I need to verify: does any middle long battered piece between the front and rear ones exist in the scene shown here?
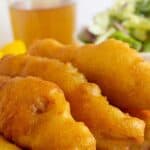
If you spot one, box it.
[0,55,145,150]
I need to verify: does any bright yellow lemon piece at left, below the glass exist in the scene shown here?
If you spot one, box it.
[0,41,27,58]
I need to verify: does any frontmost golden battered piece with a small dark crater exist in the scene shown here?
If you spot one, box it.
[0,77,96,150]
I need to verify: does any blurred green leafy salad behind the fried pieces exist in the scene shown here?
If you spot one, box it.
[79,0,150,52]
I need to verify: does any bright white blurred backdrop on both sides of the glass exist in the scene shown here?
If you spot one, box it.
[0,0,114,46]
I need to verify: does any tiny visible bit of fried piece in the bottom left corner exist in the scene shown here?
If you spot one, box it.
[0,136,21,150]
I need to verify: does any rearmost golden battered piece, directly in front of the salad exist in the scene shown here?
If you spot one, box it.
[30,39,150,109]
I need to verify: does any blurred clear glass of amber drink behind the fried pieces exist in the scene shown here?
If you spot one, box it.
[10,0,76,46]
